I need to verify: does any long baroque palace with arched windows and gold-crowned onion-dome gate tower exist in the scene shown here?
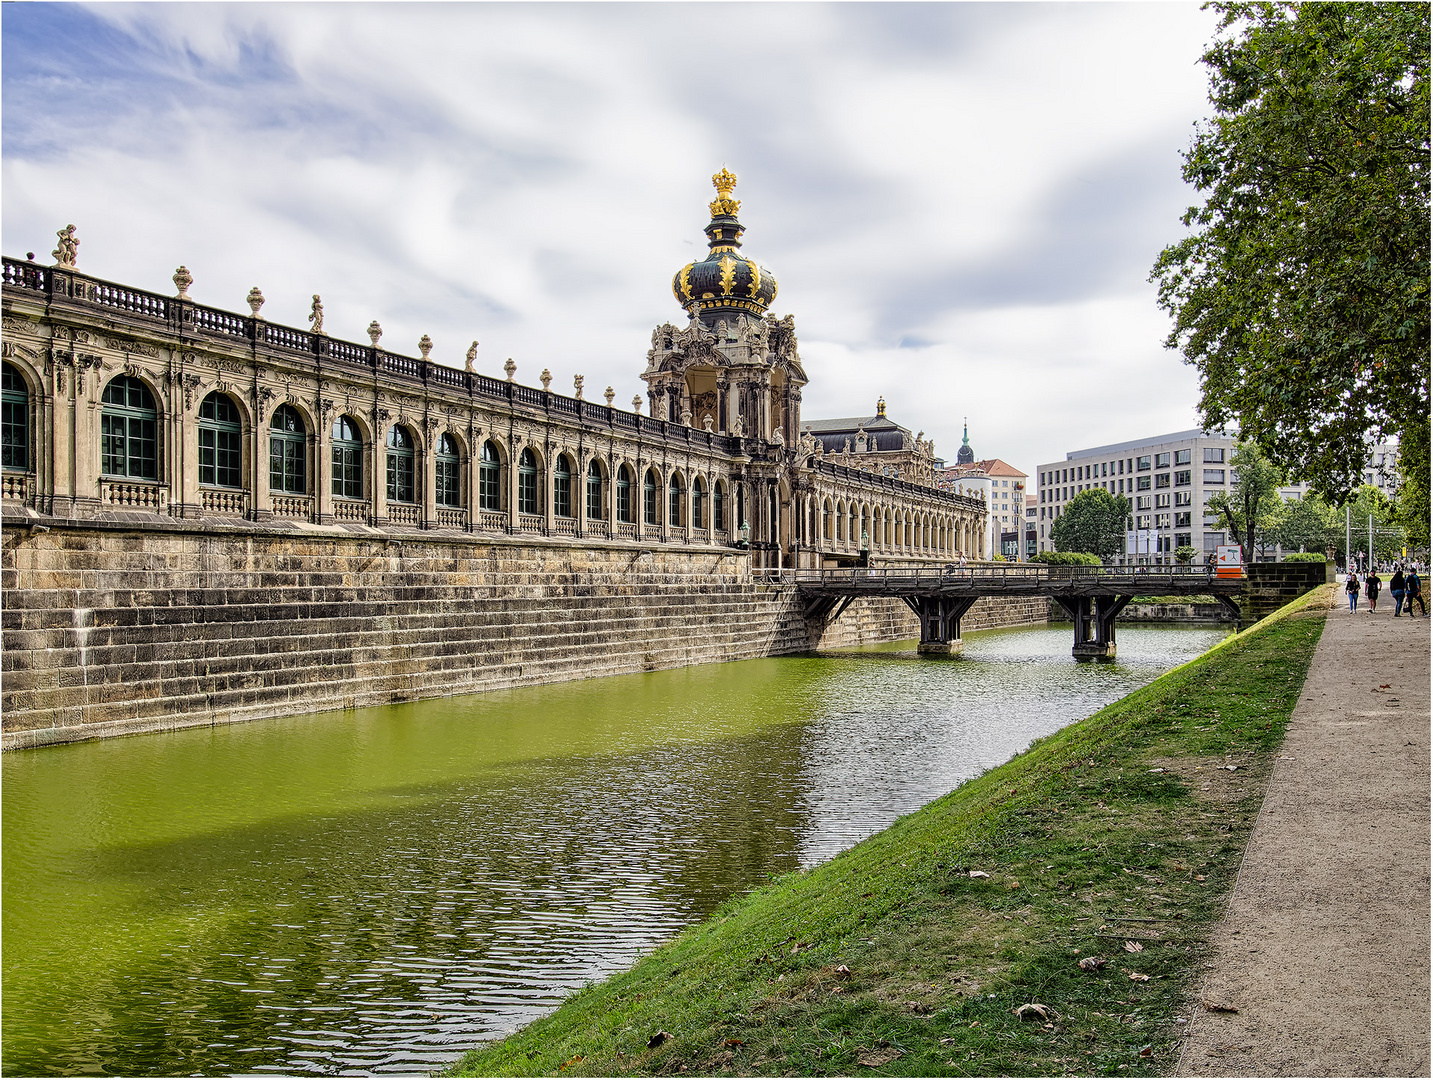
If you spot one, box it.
[0,170,989,569]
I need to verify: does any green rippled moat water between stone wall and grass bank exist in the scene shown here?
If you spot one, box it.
[0,627,1224,1076]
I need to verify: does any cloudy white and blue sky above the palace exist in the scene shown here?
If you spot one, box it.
[0,3,1215,471]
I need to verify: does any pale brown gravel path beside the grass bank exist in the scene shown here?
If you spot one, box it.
[1178,584,1430,1076]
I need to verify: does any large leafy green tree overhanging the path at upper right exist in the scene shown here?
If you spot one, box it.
[1151,1,1429,539]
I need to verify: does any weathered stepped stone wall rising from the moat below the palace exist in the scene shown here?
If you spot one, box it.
[0,519,1045,749]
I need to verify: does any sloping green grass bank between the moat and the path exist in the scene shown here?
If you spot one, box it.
[454,587,1328,1076]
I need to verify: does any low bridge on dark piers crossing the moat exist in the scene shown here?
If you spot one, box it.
[795,563,1245,660]
